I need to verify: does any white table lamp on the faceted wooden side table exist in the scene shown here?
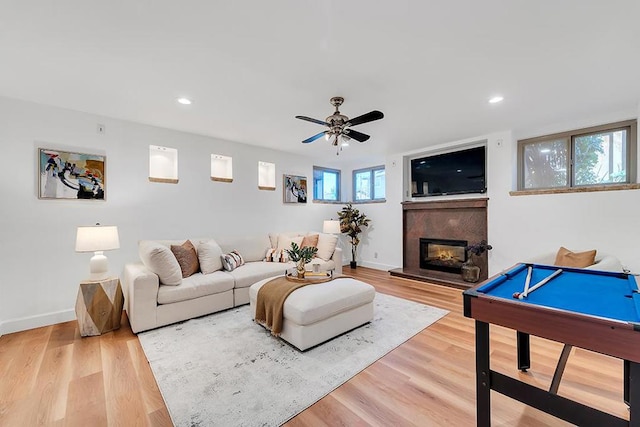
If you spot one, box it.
[76,224,120,281]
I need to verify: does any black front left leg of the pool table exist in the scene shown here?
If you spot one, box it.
[476,320,491,427]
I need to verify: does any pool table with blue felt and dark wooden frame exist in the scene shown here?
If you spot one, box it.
[463,264,640,427]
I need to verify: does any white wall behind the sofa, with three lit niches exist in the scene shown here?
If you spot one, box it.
[0,98,340,334]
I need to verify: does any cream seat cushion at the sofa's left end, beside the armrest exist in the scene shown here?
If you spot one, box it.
[158,271,233,304]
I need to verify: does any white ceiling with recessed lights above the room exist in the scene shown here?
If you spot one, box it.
[0,0,640,164]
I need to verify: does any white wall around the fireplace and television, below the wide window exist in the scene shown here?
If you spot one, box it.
[355,109,640,274]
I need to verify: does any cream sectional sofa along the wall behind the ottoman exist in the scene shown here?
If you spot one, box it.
[122,232,342,333]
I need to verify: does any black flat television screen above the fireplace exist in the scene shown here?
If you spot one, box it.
[411,146,487,197]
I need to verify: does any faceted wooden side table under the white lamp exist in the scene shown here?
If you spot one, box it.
[76,277,124,337]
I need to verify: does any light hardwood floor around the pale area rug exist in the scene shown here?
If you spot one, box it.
[0,267,629,427]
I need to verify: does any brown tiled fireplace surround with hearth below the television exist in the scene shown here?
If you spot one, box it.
[390,198,489,289]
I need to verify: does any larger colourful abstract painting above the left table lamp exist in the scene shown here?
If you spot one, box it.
[38,148,107,200]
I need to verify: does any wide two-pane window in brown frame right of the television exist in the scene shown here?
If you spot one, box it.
[518,120,637,190]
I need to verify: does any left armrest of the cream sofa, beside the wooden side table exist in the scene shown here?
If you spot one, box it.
[123,264,160,333]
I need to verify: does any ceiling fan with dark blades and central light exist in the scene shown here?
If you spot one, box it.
[296,96,384,154]
